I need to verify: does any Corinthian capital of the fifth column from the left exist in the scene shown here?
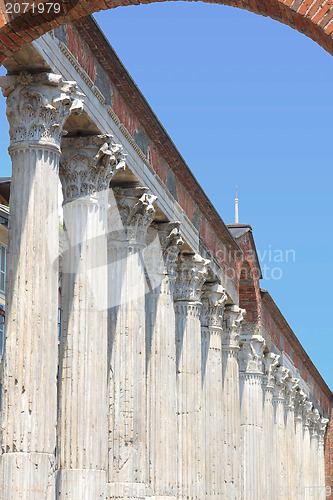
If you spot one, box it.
[174,254,210,302]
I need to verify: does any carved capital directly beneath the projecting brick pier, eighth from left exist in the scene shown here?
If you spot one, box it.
[238,335,265,374]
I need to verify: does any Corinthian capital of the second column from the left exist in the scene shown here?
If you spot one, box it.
[60,134,125,203]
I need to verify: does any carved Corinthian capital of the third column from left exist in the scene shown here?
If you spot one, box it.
[109,187,157,247]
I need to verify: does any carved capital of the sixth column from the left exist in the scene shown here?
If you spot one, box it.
[201,283,227,331]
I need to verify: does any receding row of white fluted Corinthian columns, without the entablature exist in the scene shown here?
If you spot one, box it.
[0,73,327,500]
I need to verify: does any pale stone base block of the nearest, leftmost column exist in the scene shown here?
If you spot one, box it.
[0,453,55,500]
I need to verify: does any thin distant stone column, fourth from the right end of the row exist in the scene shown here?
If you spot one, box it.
[294,390,306,498]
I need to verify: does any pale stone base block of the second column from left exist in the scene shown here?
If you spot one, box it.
[57,469,107,500]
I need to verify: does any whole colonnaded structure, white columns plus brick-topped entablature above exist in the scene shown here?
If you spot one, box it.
[0,17,332,500]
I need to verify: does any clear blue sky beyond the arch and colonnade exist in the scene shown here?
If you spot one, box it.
[0,2,333,388]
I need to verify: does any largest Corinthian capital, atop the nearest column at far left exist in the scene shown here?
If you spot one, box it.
[0,72,83,150]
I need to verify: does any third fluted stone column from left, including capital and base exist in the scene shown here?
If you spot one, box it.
[108,187,156,492]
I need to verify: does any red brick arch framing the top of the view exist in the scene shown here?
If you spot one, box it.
[0,0,333,63]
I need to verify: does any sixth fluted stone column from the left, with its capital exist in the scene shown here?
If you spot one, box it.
[201,283,227,500]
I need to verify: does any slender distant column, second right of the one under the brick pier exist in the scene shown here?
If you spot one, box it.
[273,366,290,498]
